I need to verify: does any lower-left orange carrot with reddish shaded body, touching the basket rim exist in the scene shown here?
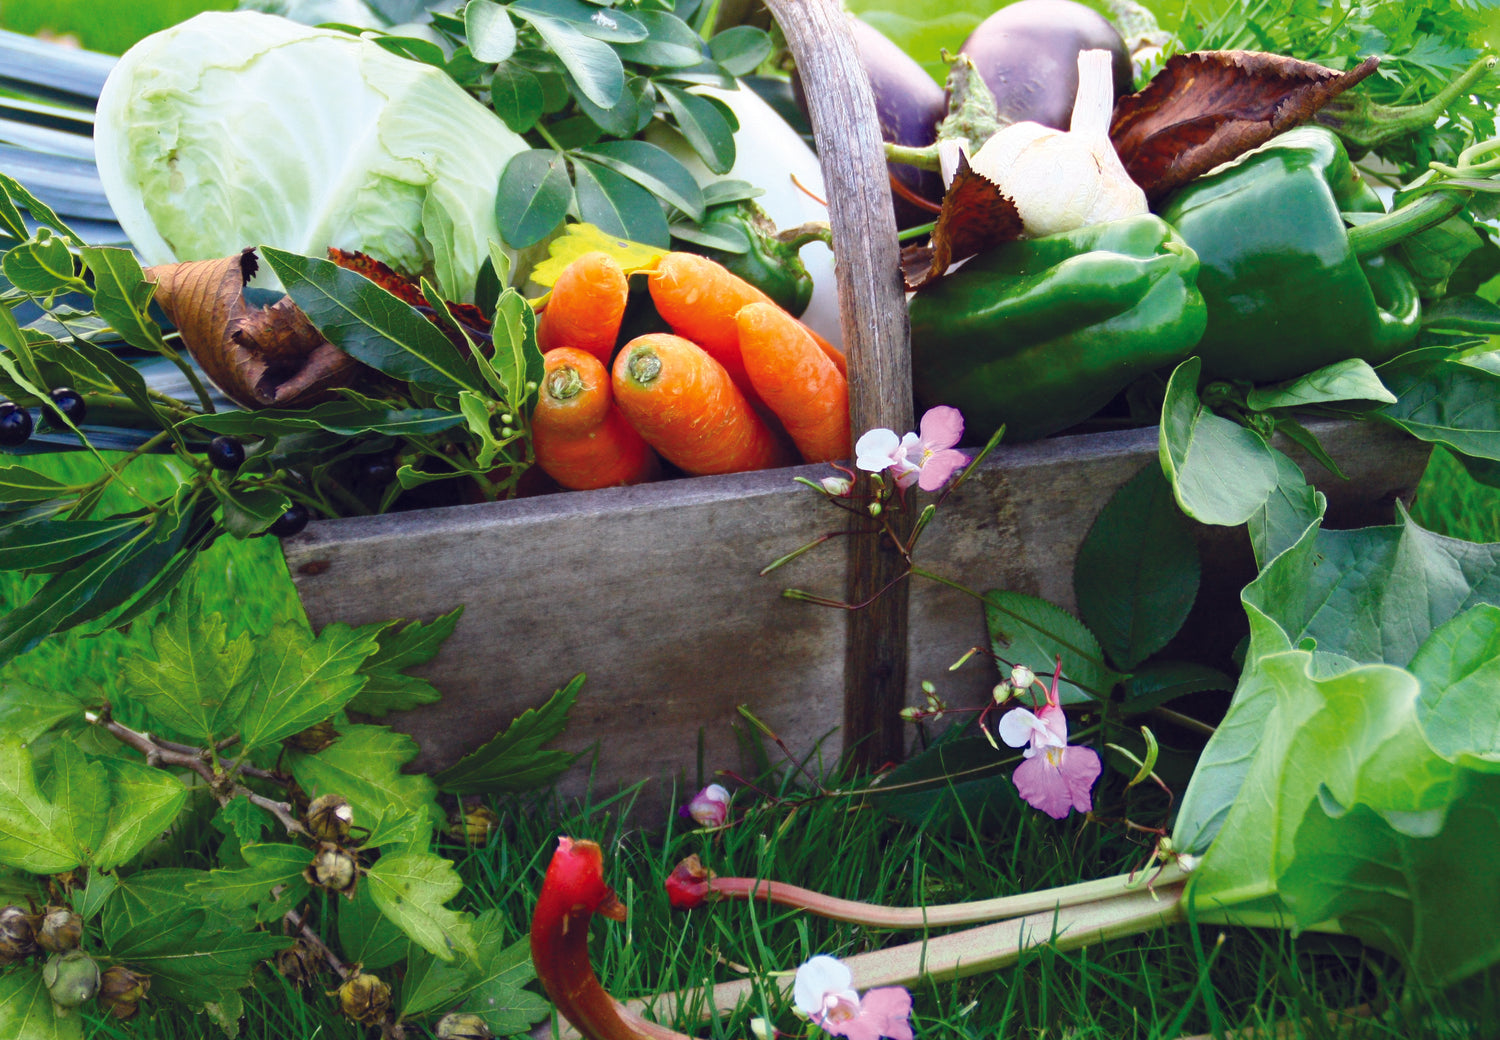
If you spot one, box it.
[531,347,657,491]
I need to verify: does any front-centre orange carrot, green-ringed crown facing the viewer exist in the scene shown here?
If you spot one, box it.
[612,332,786,474]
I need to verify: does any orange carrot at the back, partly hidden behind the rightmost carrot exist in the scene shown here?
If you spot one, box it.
[647,252,846,396]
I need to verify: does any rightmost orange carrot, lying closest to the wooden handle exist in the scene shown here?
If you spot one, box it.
[735,303,849,462]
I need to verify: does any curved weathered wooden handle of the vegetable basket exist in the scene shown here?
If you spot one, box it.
[767,0,915,768]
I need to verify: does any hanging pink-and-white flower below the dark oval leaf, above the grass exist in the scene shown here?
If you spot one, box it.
[998,659,1101,819]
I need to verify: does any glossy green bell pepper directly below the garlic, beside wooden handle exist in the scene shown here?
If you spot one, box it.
[909,213,1206,440]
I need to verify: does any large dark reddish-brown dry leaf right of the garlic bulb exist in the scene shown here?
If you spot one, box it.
[1110,51,1380,200]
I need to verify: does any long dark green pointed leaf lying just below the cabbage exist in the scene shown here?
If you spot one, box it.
[260,246,480,393]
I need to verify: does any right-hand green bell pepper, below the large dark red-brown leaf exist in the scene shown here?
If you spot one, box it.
[1160,126,1422,383]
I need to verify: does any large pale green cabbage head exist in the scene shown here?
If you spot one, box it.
[95,12,527,300]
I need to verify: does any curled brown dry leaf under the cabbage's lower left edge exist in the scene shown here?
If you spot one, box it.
[146,249,371,408]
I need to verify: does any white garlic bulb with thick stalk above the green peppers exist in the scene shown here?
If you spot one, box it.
[969,51,1146,237]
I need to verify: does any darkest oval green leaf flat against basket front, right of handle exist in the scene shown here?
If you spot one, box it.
[1073,465,1202,669]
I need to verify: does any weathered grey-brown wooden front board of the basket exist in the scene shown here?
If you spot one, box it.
[284,423,1428,821]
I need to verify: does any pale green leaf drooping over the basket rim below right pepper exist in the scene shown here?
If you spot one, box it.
[1160,357,1277,527]
